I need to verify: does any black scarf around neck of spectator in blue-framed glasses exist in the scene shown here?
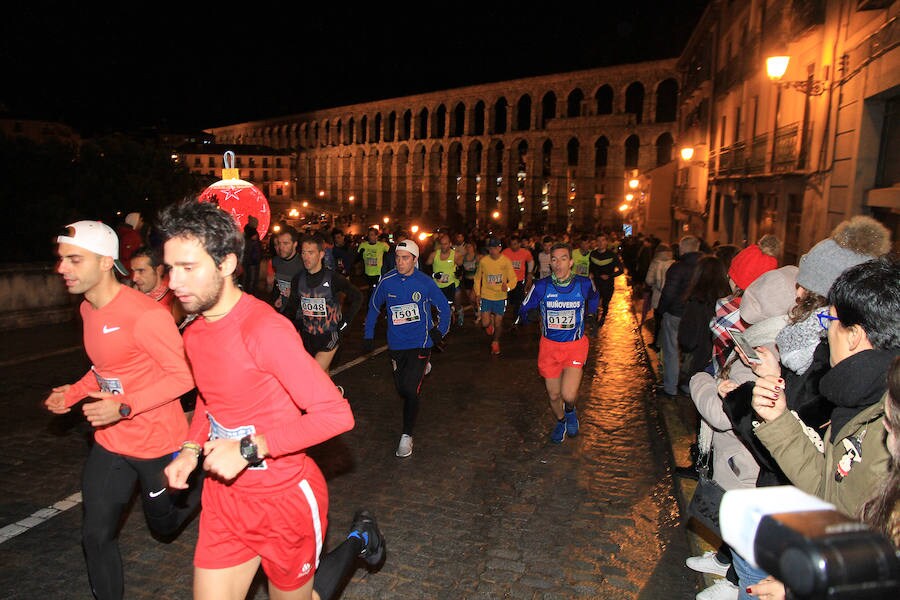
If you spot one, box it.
[819,350,897,442]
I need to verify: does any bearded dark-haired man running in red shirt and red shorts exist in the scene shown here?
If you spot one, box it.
[159,201,384,600]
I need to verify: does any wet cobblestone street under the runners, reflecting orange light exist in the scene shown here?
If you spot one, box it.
[0,277,701,600]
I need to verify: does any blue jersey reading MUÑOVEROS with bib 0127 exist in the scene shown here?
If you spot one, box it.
[519,275,600,342]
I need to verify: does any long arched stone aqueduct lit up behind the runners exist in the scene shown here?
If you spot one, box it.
[207,59,679,231]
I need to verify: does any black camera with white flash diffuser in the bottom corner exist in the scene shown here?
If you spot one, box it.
[719,486,900,600]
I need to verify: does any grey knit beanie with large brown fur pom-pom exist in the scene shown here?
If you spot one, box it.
[797,215,891,298]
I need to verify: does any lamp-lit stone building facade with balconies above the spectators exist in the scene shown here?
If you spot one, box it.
[673,0,900,264]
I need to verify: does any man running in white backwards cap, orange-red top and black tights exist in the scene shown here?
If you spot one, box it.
[45,221,199,599]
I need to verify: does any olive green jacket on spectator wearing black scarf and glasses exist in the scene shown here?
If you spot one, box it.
[754,394,889,519]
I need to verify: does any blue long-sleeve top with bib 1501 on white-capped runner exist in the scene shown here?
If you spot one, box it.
[364,269,450,350]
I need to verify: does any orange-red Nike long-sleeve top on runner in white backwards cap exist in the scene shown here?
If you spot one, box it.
[65,285,194,458]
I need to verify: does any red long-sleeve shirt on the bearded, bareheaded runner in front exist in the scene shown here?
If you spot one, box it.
[184,294,354,494]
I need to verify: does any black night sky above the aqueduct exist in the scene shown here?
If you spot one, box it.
[0,0,707,135]
